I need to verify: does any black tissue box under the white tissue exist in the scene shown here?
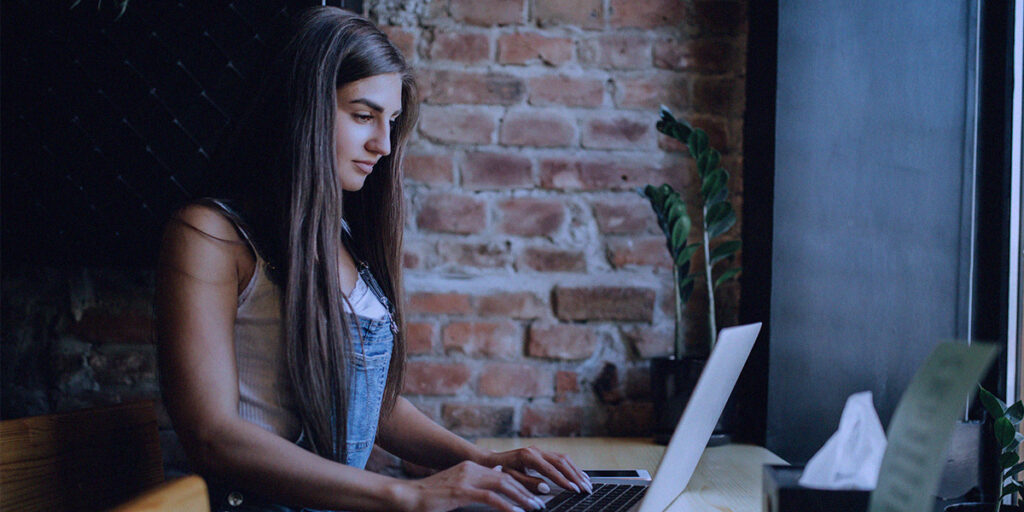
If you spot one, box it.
[762,466,871,512]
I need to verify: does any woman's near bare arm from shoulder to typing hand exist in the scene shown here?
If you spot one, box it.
[156,206,535,512]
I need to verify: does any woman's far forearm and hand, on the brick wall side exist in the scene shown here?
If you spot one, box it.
[377,396,592,493]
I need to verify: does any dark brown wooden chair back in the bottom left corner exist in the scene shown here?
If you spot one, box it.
[0,400,206,512]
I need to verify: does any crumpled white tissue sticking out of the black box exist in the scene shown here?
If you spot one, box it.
[800,391,886,490]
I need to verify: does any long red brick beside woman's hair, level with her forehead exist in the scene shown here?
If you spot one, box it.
[420,70,526,104]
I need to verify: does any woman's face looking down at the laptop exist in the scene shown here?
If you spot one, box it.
[334,73,401,191]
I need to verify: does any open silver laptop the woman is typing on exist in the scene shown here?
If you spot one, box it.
[458,323,761,512]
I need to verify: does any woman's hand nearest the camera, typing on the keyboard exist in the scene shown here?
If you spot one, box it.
[389,461,544,512]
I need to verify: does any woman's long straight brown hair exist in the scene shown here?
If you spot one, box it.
[207,7,419,462]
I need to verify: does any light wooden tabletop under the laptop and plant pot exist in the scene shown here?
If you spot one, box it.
[476,437,785,512]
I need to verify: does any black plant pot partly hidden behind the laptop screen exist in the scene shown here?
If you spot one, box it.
[650,355,738,446]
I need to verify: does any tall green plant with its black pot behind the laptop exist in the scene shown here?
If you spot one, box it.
[640,106,740,444]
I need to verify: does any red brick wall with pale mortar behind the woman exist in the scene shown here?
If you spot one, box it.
[368,0,746,436]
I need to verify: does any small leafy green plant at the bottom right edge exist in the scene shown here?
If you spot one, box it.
[945,386,1024,512]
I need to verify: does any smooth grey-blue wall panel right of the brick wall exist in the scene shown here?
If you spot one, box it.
[770,0,969,463]
